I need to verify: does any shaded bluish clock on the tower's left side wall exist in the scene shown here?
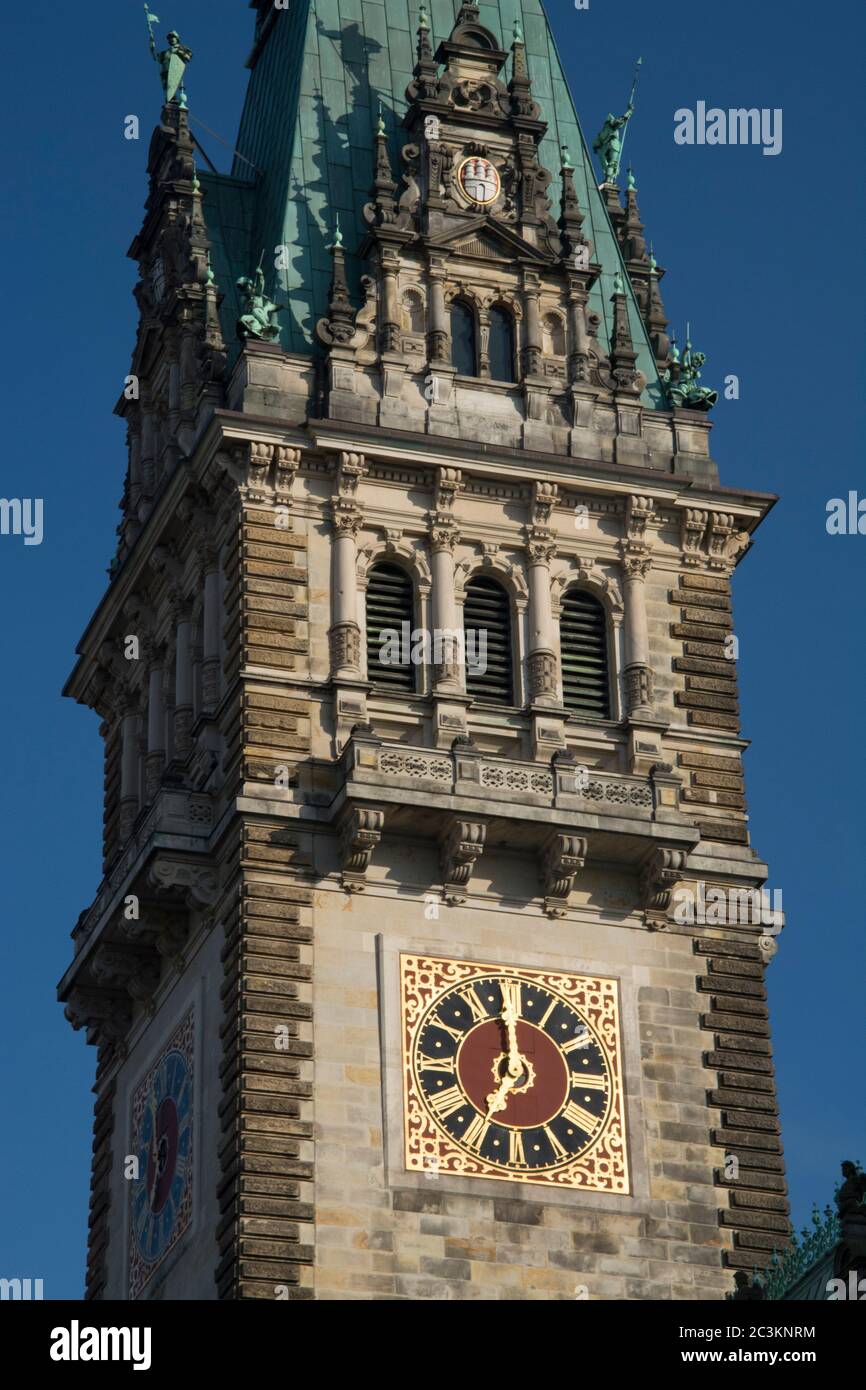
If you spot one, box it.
[131,1016,193,1297]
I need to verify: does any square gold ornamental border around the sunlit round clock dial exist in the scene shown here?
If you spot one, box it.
[400,954,631,1197]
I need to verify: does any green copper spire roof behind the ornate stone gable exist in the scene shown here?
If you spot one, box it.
[200,0,664,406]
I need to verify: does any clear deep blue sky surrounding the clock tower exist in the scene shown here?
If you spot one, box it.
[0,0,866,1297]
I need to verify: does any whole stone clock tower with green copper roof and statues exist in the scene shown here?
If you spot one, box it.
[60,0,788,1300]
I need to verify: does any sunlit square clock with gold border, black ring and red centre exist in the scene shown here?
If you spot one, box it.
[400,955,628,1193]
